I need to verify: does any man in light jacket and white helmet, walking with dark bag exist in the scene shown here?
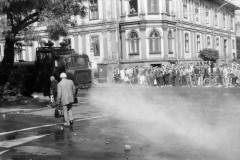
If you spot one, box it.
[57,73,75,126]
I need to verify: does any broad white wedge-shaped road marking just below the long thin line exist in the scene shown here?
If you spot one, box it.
[0,134,49,148]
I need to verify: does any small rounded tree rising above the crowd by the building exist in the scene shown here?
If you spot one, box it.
[199,48,219,62]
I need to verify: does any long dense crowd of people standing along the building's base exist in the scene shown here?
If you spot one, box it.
[113,62,240,87]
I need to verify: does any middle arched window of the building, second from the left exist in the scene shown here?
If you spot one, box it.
[149,30,161,54]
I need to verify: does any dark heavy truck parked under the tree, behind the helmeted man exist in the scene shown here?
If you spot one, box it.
[15,44,92,96]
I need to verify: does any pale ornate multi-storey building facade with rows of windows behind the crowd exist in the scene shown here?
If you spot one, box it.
[0,0,239,79]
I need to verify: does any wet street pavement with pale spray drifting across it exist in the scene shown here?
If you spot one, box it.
[0,84,240,160]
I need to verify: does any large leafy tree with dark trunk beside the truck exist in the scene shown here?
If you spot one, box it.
[0,0,87,69]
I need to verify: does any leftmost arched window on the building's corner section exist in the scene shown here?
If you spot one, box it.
[129,31,139,54]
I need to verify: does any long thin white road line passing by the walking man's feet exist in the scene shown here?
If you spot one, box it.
[0,116,107,136]
